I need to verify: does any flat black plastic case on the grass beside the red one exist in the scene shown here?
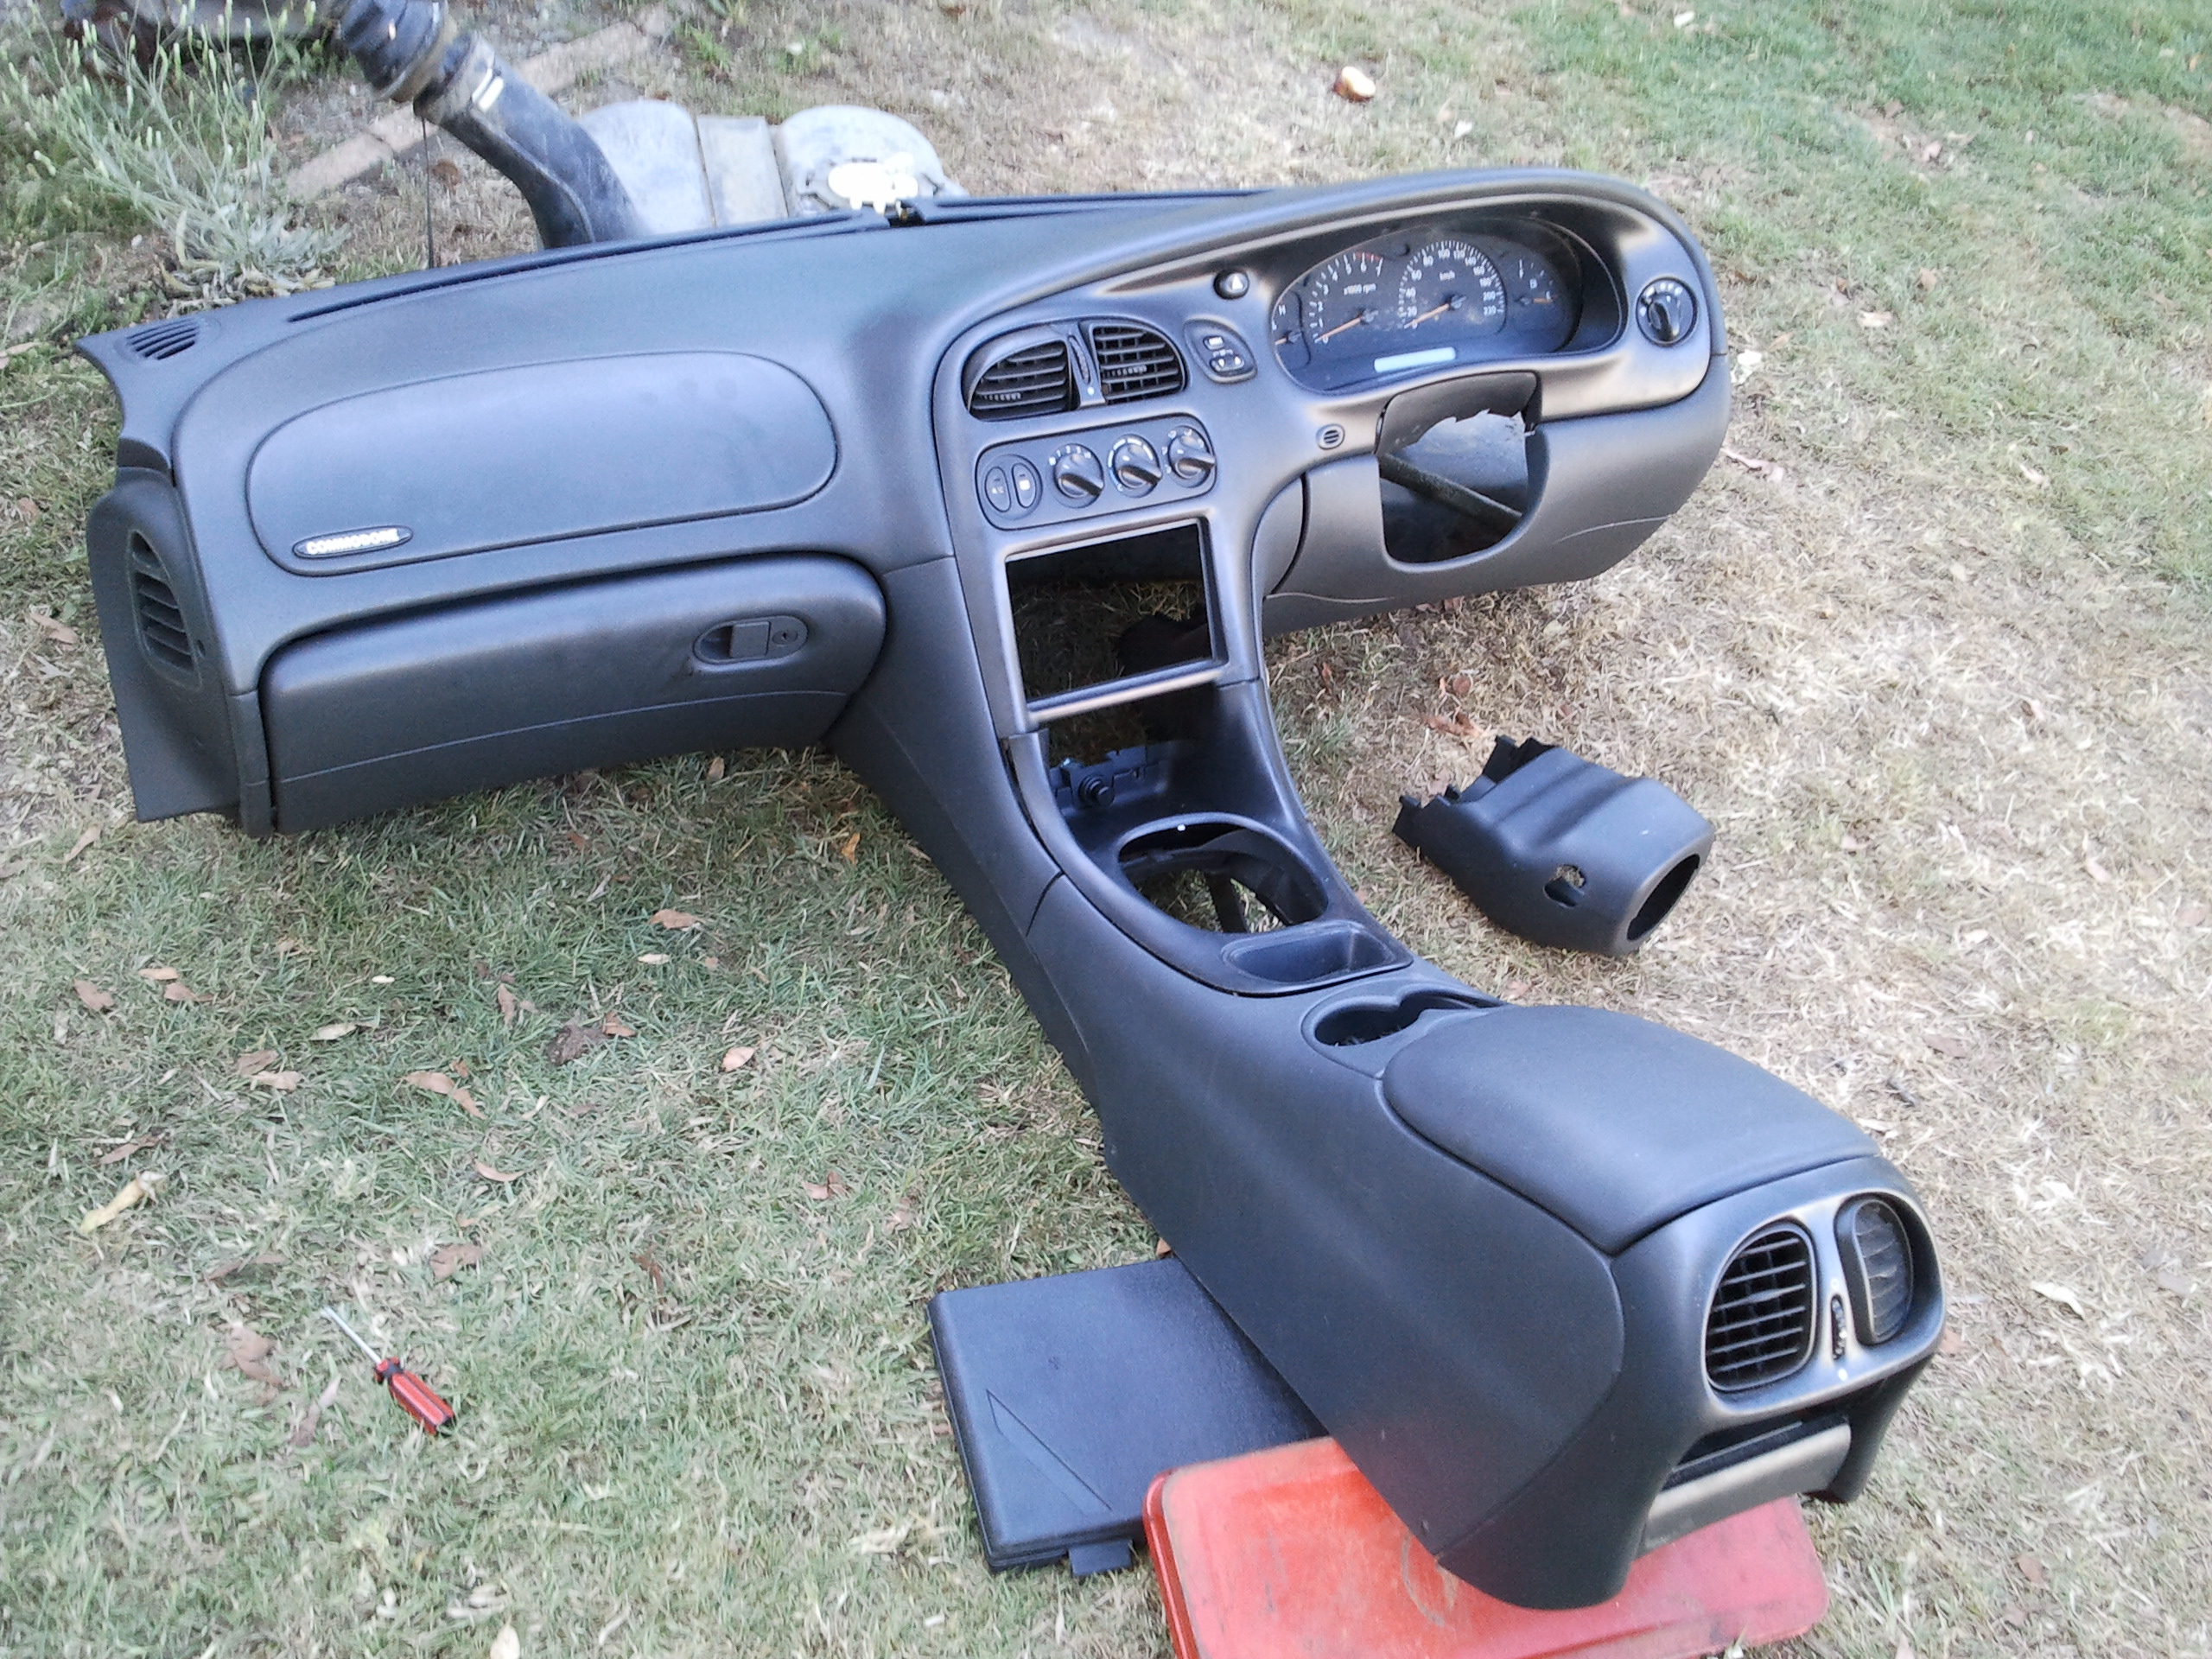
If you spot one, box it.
[929,1256,1323,1573]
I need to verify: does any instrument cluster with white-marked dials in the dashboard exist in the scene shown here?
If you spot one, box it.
[1269,224,1581,391]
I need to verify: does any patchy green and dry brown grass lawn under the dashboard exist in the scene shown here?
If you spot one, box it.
[0,0,2212,1659]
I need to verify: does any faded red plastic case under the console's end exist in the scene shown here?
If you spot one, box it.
[1144,1440,1827,1659]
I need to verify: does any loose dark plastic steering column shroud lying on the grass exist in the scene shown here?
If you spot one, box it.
[1395,739,1712,956]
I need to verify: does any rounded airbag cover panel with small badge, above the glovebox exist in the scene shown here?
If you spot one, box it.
[245,352,836,573]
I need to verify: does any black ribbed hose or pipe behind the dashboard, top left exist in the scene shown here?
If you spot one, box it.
[339,0,646,248]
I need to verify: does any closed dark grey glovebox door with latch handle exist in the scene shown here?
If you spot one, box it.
[261,556,882,830]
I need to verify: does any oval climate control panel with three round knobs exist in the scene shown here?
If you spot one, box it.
[976,416,1214,531]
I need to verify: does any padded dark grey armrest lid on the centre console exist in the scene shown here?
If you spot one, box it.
[1382,1008,1873,1255]
